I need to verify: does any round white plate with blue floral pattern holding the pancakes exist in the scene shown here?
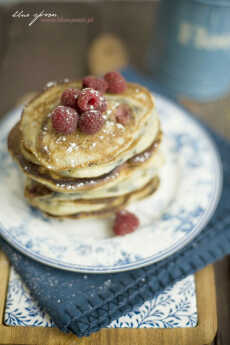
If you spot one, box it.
[0,95,222,273]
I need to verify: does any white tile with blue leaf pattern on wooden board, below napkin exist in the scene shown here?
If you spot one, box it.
[4,269,198,328]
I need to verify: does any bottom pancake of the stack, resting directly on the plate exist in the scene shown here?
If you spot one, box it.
[25,176,159,218]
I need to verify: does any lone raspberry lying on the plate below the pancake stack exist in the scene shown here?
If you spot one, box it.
[113,210,139,236]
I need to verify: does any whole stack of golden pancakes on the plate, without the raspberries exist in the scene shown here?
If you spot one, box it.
[8,82,163,218]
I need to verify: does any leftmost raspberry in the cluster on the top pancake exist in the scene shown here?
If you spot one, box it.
[51,105,78,134]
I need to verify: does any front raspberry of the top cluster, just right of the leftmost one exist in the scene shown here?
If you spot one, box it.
[78,110,105,134]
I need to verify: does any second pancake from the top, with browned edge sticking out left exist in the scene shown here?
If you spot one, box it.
[8,124,162,197]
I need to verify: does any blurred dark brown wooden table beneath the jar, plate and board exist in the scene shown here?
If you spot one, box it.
[0,1,230,345]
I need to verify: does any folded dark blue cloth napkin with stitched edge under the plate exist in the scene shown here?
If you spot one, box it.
[0,70,230,337]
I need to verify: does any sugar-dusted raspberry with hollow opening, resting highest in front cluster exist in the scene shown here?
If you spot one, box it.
[77,88,101,112]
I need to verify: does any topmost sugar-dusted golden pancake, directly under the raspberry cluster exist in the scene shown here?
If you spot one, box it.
[20,82,159,177]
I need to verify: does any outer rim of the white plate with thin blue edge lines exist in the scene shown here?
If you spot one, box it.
[0,92,223,274]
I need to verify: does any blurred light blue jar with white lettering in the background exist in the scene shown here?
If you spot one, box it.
[148,0,230,100]
